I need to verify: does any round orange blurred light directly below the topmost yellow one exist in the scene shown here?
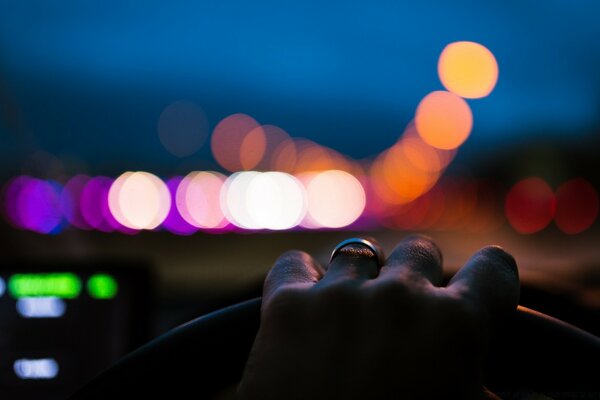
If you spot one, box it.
[415,91,473,150]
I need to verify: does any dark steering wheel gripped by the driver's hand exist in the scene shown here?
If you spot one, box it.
[71,298,600,400]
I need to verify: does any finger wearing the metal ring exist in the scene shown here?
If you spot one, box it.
[319,239,379,285]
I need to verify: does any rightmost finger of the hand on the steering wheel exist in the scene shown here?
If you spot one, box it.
[448,246,520,315]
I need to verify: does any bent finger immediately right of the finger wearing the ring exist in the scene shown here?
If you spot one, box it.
[379,235,442,286]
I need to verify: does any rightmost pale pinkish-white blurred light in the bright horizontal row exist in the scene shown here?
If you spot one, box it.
[301,170,366,228]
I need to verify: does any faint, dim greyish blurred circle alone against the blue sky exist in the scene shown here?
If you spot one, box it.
[157,100,208,157]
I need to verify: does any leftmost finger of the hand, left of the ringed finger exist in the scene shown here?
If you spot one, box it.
[263,250,323,303]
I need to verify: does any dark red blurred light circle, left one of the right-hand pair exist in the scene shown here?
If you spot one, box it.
[504,177,555,234]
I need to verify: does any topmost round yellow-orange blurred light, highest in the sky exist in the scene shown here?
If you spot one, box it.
[438,42,498,99]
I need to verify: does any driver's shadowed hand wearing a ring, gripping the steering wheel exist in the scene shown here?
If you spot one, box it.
[238,236,519,400]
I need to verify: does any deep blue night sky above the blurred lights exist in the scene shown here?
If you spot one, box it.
[0,0,600,173]
